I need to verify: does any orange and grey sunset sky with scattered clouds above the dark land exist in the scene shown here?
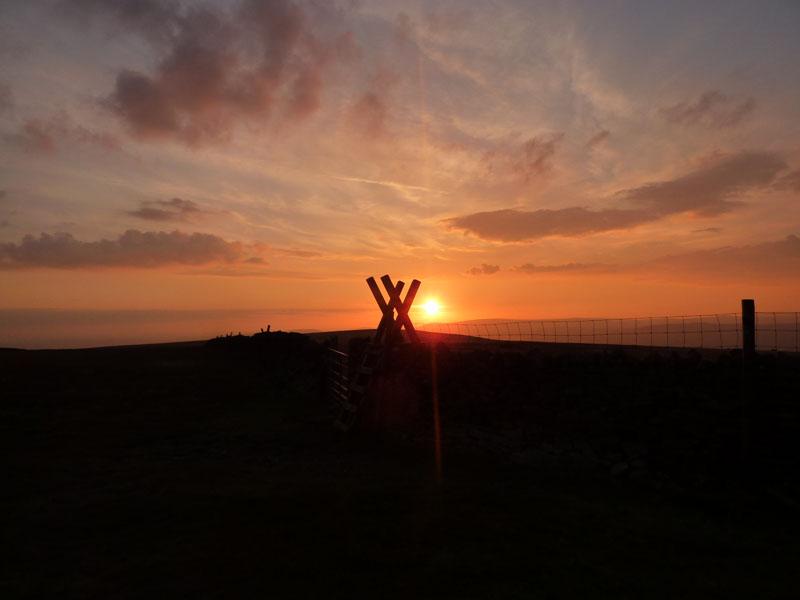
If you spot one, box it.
[0,0,800,348]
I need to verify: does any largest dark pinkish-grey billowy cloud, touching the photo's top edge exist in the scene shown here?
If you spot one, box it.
[85,0,357,145]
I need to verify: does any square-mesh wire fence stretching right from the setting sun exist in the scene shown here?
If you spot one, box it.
[418,312,800,352]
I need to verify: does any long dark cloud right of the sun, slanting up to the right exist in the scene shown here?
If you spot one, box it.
[443,152,787,242]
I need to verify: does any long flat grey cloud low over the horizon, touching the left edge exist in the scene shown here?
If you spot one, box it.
[0,229,250,269]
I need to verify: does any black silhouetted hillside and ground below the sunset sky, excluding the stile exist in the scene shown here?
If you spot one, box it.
[6,332,800,598]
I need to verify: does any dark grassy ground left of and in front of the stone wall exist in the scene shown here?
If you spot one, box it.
[0,337,800,598]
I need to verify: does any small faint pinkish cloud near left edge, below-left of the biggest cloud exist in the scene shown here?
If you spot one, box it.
[11,114,120,156]
